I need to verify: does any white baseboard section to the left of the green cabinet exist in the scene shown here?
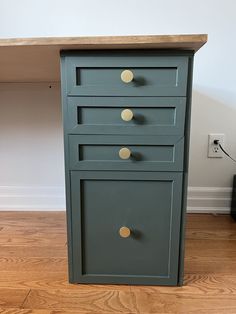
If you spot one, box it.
[0,186,66,211]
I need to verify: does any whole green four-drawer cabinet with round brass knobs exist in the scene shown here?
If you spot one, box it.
[61,50,193,285]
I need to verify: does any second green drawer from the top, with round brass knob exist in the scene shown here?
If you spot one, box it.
[65,97,186,135]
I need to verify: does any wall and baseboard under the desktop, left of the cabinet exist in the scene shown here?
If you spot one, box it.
[0,83,65,209]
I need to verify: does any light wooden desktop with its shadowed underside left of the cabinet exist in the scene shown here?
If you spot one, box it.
[0,34,207,82]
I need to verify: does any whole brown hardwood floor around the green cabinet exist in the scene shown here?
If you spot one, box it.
[0,212,236,314]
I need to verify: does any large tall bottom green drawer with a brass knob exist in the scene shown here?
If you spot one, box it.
[71,171,182,285]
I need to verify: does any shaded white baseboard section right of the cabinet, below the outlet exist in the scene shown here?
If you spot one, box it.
[187,187,232,214]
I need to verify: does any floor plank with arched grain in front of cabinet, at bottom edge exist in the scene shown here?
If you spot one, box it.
[24,289,136,314]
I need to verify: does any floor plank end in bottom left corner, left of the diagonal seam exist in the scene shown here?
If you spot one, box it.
[0,287,30,308]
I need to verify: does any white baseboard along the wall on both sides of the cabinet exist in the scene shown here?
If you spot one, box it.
[0,186,232,214]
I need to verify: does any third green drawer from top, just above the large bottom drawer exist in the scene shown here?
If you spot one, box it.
[69,135,184,171]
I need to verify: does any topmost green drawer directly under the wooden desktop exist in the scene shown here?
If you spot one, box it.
[63,52,188,96]
